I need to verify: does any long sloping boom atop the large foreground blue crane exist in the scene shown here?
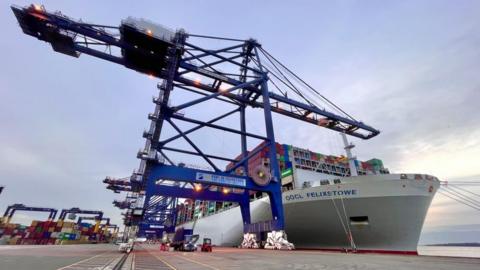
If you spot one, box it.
[12,5,380,139]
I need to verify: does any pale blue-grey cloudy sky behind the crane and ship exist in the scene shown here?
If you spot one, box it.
[0,0,480,243]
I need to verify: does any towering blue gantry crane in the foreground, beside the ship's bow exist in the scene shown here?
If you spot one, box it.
[12,5,379,240]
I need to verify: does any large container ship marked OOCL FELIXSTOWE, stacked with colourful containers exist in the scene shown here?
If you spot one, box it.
[177,137,440,255]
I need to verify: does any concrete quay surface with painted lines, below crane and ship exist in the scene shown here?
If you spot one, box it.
[0,244,480,270]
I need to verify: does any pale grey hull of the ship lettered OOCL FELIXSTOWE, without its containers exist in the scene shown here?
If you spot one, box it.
[181,174,439,254]
